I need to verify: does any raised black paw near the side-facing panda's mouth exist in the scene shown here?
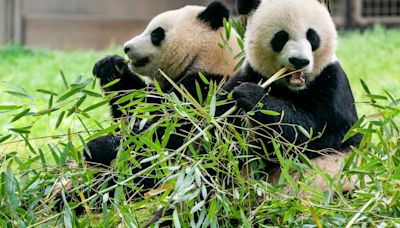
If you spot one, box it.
[93,55,128,84]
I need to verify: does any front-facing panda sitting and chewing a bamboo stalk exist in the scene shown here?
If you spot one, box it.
[217,0,361,194]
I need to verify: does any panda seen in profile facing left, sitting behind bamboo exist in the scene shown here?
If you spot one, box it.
[85,2,241,166]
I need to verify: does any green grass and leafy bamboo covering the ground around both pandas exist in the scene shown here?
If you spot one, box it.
[0,27,400,227]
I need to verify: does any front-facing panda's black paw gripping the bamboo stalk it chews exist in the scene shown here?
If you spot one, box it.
[232,82,265,112]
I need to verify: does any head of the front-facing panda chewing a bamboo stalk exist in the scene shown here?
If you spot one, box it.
[238,0,337,91]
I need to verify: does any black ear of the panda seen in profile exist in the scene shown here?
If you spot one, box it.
[198,1,229,30]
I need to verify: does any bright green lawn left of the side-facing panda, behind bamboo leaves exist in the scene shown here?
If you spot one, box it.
[0,45,123,136]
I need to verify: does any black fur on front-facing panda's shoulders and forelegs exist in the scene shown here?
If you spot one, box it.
[217,62,361,158]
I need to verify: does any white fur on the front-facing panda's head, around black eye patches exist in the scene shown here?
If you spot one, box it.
[245,0,337,86]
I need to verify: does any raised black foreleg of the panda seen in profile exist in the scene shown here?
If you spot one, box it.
[93,55,147,119]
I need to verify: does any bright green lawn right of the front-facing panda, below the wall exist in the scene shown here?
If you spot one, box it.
[337,27,400,114]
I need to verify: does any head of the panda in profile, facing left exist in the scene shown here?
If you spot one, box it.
[124,2,240,85]
